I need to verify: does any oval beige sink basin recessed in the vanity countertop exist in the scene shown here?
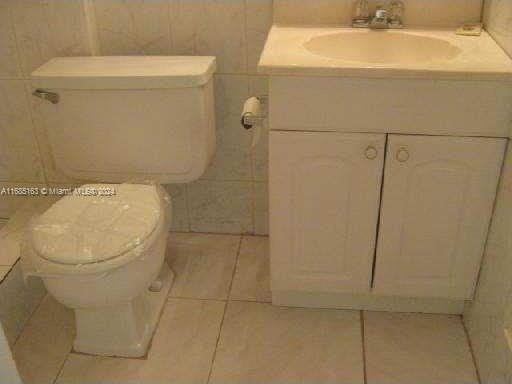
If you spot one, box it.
[304,31,461,65]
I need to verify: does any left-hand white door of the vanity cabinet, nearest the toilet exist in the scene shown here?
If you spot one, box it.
[269,131,386,292]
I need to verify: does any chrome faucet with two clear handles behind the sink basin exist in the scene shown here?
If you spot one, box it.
[352,0,404,29]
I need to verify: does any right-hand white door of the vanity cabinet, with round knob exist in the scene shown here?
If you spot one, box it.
[374,135,506,299]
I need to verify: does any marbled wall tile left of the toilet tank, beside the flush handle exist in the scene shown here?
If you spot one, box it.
[0,80,44,182]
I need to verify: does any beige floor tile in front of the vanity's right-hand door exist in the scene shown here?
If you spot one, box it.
[364,312,478,384]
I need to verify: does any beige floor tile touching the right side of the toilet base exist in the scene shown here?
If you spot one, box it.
[167,233,240,300]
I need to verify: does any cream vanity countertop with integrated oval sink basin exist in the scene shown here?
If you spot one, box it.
[258,26,512,81]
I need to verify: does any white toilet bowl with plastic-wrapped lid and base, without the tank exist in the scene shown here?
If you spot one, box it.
[24,184,172,357]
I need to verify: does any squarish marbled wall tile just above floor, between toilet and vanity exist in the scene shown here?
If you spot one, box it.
[187,180,253,233]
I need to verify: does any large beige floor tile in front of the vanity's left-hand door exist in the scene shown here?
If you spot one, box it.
[210,301,363,384]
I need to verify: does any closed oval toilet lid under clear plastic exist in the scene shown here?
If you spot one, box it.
[31,184,162,265]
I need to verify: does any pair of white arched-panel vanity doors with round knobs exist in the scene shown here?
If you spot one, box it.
[270,131,506,300]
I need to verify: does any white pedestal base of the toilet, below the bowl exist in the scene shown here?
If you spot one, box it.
[73,261,174,357]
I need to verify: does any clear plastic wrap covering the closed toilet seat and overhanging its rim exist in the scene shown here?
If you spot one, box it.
[21,182,171,278]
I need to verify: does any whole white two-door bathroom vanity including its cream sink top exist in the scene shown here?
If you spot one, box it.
[258,25,512,314]
